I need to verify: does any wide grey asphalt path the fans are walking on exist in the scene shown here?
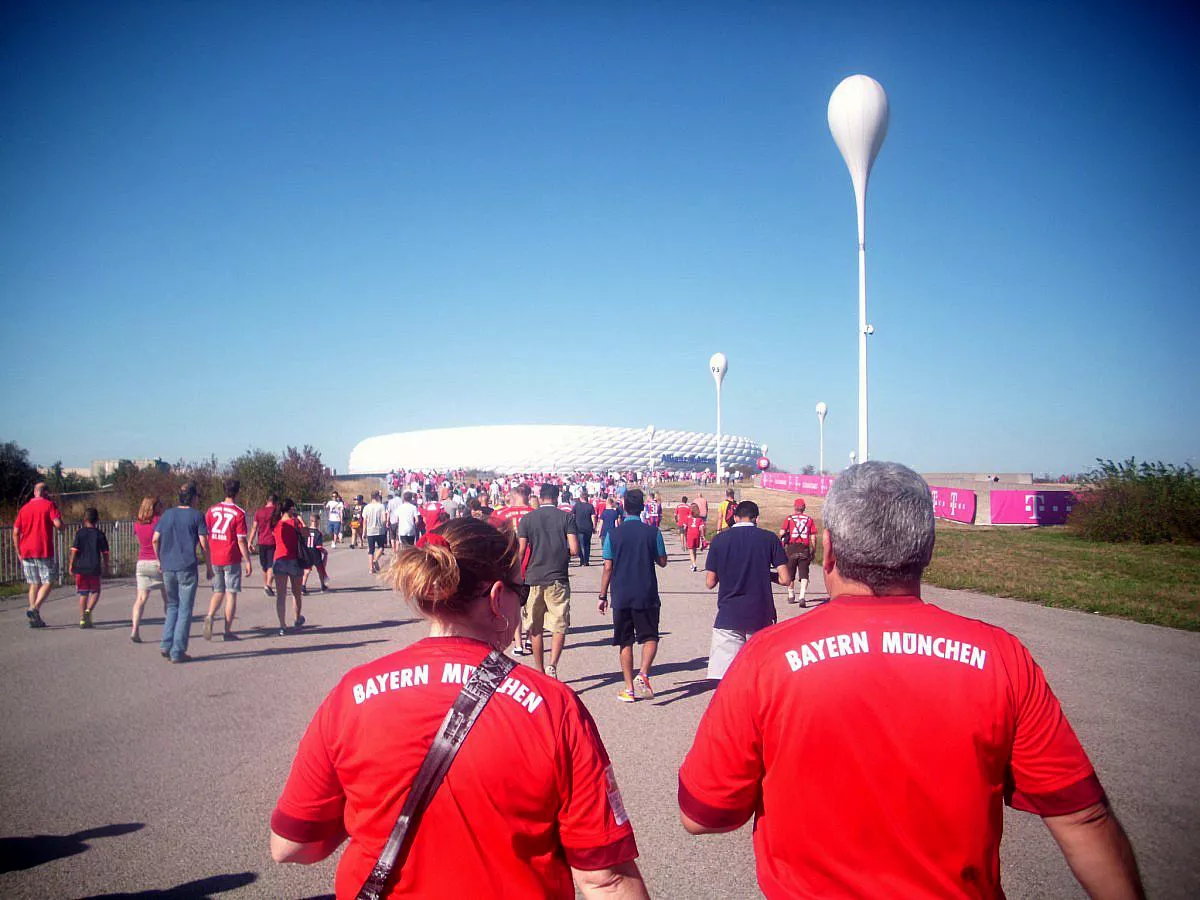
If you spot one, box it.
[0,536,1200,900]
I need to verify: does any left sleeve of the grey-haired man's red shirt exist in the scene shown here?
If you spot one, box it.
[679,648,764,828]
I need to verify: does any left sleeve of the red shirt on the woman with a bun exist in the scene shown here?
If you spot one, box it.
[271,698,346,844]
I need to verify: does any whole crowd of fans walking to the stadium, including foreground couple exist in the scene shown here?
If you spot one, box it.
[7,462,1144,898]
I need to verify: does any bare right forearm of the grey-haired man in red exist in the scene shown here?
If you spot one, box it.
[1042,803,1146,900]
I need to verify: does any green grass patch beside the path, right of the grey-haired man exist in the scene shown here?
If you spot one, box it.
[924,523,1200,631]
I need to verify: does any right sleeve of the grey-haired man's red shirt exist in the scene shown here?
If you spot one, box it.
[1004,638,1106,816]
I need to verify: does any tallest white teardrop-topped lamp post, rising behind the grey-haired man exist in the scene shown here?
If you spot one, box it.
[829,74,888,462]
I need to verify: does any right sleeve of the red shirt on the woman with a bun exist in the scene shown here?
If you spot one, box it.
[558,696,637,870]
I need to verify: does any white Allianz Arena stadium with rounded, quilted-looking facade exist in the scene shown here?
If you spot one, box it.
[348,425,762,475]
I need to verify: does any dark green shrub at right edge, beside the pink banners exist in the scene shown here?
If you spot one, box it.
[1068,457,1200,544]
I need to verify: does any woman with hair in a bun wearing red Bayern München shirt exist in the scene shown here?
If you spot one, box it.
[270,510,647,900]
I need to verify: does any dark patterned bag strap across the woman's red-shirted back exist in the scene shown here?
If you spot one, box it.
[358,650,517,900]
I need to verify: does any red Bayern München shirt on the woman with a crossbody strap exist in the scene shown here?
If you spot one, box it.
[271,637,637,900]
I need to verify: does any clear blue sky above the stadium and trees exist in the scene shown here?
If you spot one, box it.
[0,2,1200,473]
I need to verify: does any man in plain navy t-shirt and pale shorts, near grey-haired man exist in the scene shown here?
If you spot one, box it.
[704,500,792,679]
